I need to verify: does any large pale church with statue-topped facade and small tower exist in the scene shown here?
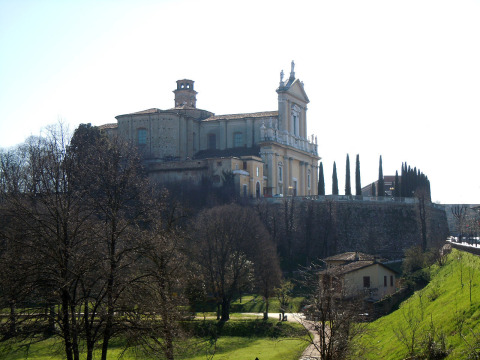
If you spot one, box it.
[101,61,320,197]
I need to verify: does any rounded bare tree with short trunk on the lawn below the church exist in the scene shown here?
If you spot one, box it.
[191,205,276,321]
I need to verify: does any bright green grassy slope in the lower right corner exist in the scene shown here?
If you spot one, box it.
[359,250,480,360]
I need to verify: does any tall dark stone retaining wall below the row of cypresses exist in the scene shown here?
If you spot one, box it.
[258,197,449,268]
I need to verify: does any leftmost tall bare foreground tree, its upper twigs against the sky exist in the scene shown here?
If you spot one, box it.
[2,124,89,360]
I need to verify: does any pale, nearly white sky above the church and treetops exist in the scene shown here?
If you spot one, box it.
[0,0,480,204]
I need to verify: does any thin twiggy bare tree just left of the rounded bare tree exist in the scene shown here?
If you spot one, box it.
[126,211,188,360]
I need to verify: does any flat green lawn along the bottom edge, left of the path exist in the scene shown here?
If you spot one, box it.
[0,317,307,360]
